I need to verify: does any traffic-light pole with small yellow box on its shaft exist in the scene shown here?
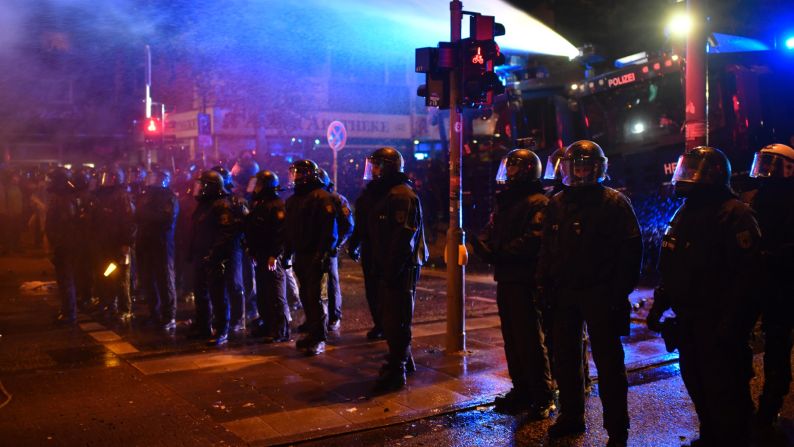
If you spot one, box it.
[446,0,466,353]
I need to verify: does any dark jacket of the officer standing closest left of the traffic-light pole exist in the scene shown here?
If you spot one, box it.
[366,173,428,278]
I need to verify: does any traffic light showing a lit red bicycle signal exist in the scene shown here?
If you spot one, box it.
[459,15,505,107]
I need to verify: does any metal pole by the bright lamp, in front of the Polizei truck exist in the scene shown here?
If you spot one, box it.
[684,0,707,152]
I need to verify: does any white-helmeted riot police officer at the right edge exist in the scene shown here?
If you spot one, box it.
[750,144,794,429]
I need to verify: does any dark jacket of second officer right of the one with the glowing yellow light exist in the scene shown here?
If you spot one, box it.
[188,196,242,265]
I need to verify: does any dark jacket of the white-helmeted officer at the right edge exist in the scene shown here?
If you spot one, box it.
[750,179,794,290]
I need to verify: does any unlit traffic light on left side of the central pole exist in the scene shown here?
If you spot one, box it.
[415,42,455,109]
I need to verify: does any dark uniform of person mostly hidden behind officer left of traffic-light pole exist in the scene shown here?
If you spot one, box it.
[347,182,383,338]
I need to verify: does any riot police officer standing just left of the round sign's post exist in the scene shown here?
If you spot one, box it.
[285,160,337,355]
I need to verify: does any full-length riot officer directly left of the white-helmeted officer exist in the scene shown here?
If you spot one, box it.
[648,147,760,446]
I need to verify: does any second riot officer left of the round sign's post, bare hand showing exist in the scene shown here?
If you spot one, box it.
[246,171,290,343]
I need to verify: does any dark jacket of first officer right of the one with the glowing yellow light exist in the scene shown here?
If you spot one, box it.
[135,187,179,250]
